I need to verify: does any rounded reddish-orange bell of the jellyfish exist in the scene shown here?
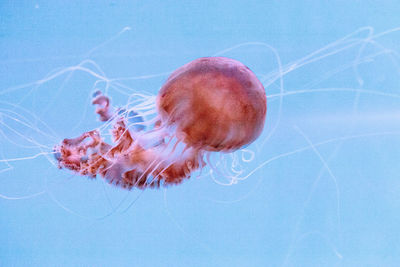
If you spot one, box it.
[157,57,267,151]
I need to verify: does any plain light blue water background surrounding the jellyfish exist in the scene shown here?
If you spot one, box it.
[0,0,400,266]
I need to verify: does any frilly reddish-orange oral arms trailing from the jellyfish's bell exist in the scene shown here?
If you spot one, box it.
[55,117,205,189]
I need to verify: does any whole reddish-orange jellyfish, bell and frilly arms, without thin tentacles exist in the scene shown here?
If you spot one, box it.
[54,57,267,189]
